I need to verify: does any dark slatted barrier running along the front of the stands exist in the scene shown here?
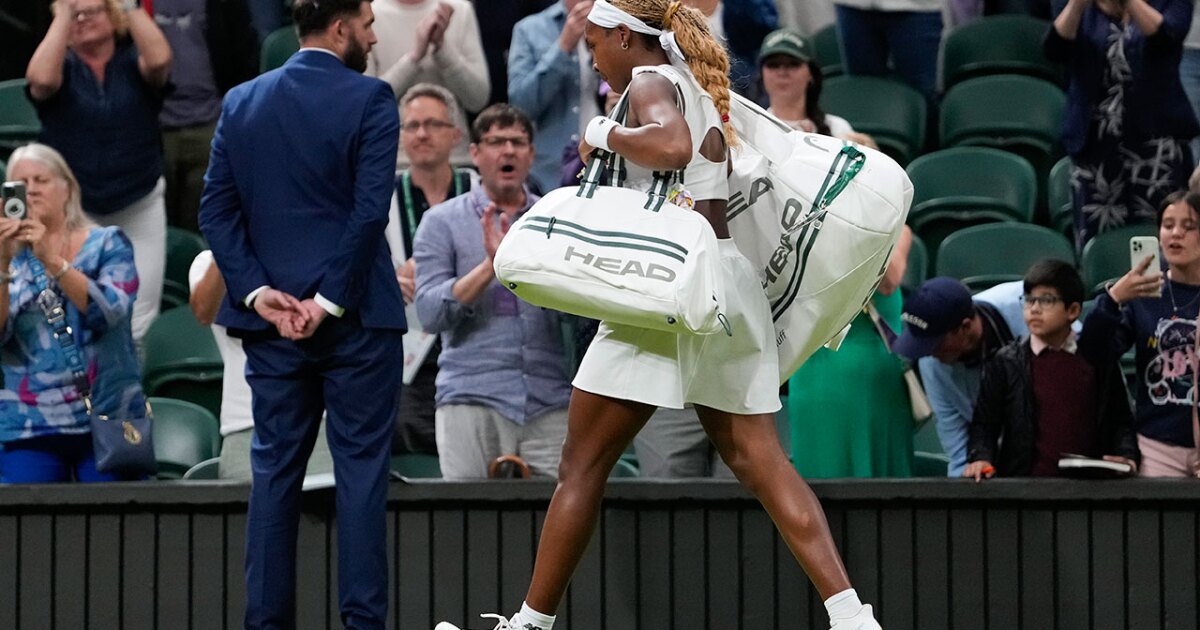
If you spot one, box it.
[0,480,1200,630]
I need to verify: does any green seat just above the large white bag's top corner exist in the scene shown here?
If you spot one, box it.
[821,77,926,166]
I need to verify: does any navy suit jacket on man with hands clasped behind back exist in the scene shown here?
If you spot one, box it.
[199,50,407,331]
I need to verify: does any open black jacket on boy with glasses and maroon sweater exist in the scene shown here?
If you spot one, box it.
[967,336,1141,476]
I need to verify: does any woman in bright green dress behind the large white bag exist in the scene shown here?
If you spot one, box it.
[787,227,913,479]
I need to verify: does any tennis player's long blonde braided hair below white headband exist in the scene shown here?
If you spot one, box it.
[610,0,737,145]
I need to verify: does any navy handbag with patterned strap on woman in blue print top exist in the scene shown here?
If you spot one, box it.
[29,256,158,478]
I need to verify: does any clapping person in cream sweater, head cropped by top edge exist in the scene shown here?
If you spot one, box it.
[366,0,491,168]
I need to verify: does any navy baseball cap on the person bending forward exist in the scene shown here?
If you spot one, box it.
[892,277,974,360]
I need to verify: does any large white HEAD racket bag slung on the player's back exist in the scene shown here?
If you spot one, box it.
[727,95,912,382]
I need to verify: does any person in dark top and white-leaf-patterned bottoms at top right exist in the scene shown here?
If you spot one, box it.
[1044,0,1200,251]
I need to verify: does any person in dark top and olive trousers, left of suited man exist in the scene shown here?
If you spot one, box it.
[154,0,258,232]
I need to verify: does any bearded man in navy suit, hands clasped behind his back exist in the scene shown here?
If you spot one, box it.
[199,0,406,629]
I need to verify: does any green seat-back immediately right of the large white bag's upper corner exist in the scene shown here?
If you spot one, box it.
[906,146,1037,269]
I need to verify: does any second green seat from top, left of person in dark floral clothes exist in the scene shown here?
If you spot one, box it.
[938,74,1067,214]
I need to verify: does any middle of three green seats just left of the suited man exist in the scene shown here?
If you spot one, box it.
[142,306,224,416]
